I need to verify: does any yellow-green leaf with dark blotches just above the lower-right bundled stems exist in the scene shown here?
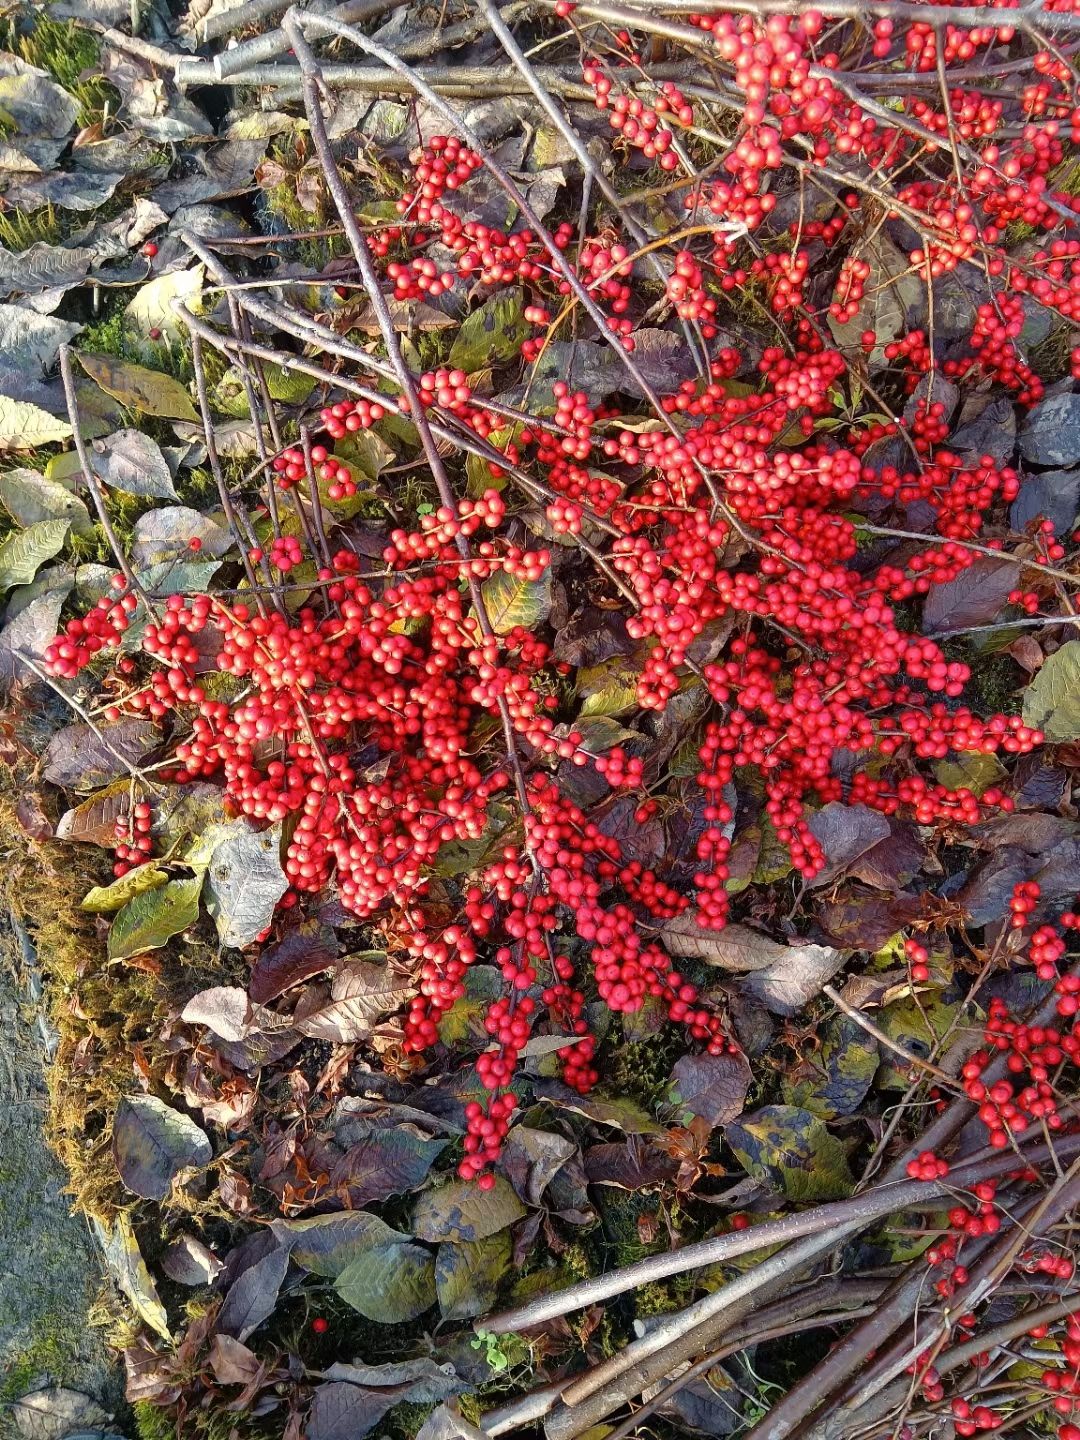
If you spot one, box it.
[724,1104,855,1201]
